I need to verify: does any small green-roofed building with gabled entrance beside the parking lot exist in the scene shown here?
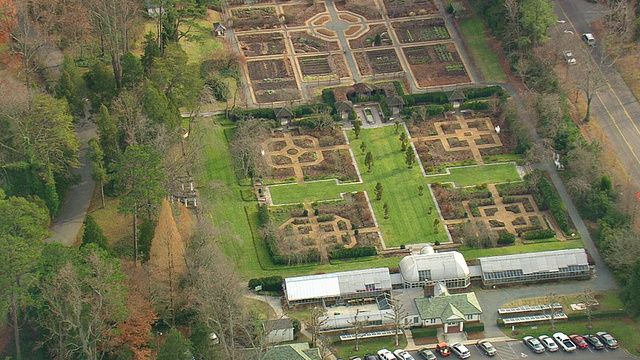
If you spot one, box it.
[415,285,482,334]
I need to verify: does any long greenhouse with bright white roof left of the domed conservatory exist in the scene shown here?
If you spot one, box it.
[283,268,391,306]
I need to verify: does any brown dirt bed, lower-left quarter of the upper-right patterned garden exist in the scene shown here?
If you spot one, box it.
[414,140,475,174]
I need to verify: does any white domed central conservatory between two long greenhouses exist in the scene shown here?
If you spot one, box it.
[399,246,471,289]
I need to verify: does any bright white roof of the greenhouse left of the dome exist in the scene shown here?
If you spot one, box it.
[284,268,391,301]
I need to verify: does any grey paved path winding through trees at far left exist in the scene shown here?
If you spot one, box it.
[47,122,96,246]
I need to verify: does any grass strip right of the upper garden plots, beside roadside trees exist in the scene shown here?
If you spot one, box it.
[460,16,507,82]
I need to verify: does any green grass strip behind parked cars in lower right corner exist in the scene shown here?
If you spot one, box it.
[501,318,640,356]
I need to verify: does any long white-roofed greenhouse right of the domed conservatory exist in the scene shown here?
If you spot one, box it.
[479,249,591,285]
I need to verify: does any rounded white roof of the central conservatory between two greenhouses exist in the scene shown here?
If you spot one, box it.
[399,251,469,282]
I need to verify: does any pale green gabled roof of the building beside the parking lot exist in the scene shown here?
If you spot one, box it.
[415,292,482,322]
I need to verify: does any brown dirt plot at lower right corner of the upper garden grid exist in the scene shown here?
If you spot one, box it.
[403,43,471,88]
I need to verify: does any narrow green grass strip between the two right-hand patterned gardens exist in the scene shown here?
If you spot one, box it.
[427,163,520,187]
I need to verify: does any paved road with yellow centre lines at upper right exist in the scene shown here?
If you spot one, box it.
[555,0,640,187]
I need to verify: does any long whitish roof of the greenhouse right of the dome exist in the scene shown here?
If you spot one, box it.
[479,249,589,274]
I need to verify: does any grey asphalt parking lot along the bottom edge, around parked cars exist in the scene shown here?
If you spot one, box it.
[409,341,635,360]
